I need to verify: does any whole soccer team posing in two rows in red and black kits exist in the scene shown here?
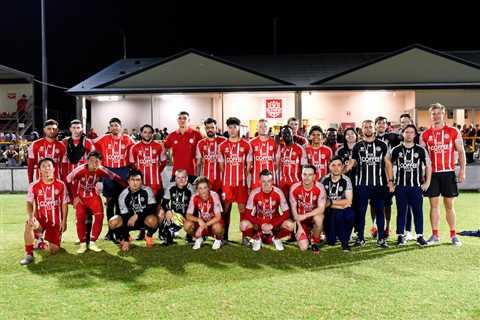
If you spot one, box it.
[20,103,465,265]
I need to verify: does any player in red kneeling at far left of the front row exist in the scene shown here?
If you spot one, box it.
[20,158,69,265]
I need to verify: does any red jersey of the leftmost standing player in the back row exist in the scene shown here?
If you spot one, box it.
[28,138,66,183]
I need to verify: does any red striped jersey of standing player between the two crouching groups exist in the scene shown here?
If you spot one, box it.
[218,139,252,187]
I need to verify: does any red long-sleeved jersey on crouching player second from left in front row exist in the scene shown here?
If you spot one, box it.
[67,164,127,201]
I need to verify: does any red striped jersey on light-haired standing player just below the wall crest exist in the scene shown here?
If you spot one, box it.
[250,137,277,189]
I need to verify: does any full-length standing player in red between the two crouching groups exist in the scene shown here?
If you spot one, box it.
[219,117,252,241]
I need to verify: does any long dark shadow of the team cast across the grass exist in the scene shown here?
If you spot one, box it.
[28,241,424,290]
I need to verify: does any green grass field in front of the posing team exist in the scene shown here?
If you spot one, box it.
[0,193,480,319]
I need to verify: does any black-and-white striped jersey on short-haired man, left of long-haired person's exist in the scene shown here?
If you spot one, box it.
[352,138,388,187]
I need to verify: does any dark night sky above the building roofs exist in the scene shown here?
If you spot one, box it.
[0,0,480,121]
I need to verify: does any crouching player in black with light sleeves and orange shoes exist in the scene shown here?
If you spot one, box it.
[108,170,158,252]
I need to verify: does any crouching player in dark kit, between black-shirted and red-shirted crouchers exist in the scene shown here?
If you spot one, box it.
[158,169,195,245]
